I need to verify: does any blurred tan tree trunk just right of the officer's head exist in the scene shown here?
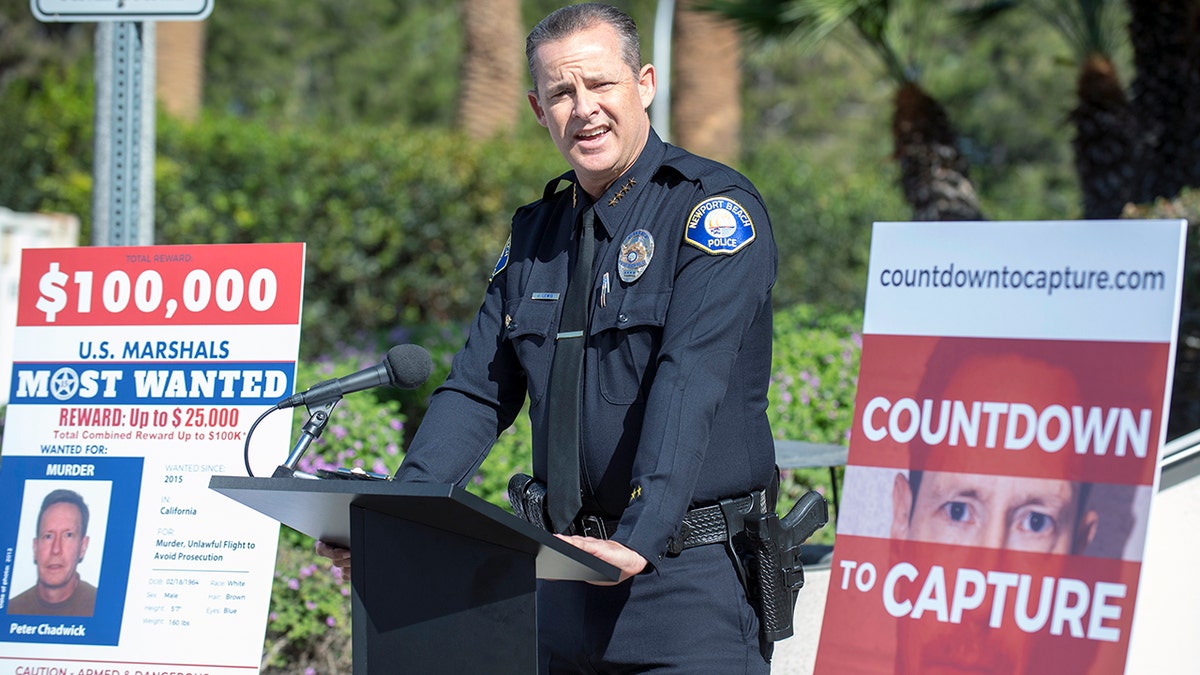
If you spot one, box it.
[671,0,742,165]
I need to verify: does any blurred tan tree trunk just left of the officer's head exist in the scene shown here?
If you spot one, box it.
[458,0,528,138]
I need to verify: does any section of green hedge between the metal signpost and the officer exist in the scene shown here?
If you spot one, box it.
[157,118,562,354]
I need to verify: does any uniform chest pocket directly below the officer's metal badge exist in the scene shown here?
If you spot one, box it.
[589,291,671,405]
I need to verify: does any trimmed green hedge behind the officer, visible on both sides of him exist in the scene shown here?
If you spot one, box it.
[0,60,883,358]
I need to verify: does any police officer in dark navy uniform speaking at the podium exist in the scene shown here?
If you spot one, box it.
[316,4,776,675]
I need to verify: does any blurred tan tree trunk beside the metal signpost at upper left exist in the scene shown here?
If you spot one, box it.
[155,22,205,121]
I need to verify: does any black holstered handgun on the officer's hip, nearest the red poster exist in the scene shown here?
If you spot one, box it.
[722,490,829,641]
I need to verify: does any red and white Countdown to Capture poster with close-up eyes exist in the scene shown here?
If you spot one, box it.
[814,220,1194,675]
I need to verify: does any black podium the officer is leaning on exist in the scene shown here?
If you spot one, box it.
[209,476,618,675]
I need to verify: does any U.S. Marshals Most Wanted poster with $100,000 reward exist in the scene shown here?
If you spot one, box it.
[0,244,304,675]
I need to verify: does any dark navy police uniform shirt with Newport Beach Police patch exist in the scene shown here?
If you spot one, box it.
[397,130,778,565]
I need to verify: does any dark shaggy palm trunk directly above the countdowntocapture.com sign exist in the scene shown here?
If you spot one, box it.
[892,82,983,221]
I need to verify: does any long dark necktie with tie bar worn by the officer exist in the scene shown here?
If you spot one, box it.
[546,207,595,532]
